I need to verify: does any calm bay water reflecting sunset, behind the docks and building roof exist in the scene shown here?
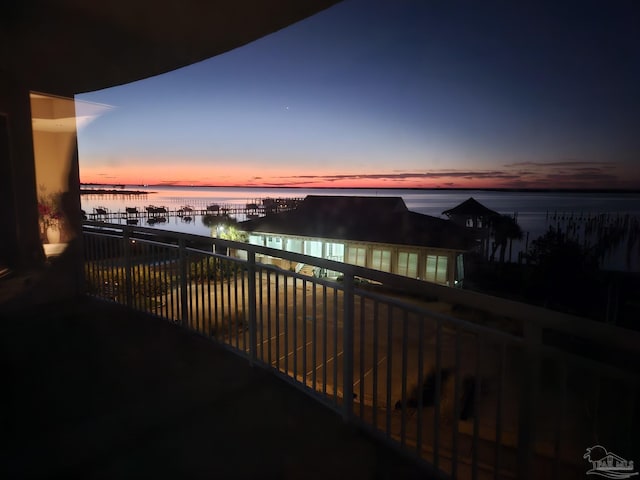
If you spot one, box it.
[81,186,640,271]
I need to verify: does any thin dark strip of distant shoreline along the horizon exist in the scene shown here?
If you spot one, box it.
[80,183,640,195]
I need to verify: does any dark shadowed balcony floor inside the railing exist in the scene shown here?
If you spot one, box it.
[0,298,428,479]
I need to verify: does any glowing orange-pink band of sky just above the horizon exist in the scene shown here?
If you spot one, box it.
[80,159,640,189]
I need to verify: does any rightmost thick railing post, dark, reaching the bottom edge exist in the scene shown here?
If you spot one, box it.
[518,322,542,480]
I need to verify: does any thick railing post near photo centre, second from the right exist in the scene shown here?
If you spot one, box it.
[342,273,354,422]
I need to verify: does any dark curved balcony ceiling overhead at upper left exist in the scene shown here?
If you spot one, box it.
[0,0,339,95]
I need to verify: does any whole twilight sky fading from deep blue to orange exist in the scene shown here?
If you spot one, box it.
[76,0,640,188]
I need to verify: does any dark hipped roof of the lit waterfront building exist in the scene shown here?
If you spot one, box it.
[240,195,471,250]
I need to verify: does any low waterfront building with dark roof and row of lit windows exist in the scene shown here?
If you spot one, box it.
[240,195,473,286]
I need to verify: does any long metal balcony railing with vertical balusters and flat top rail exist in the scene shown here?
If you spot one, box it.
[84,222,640,478]
